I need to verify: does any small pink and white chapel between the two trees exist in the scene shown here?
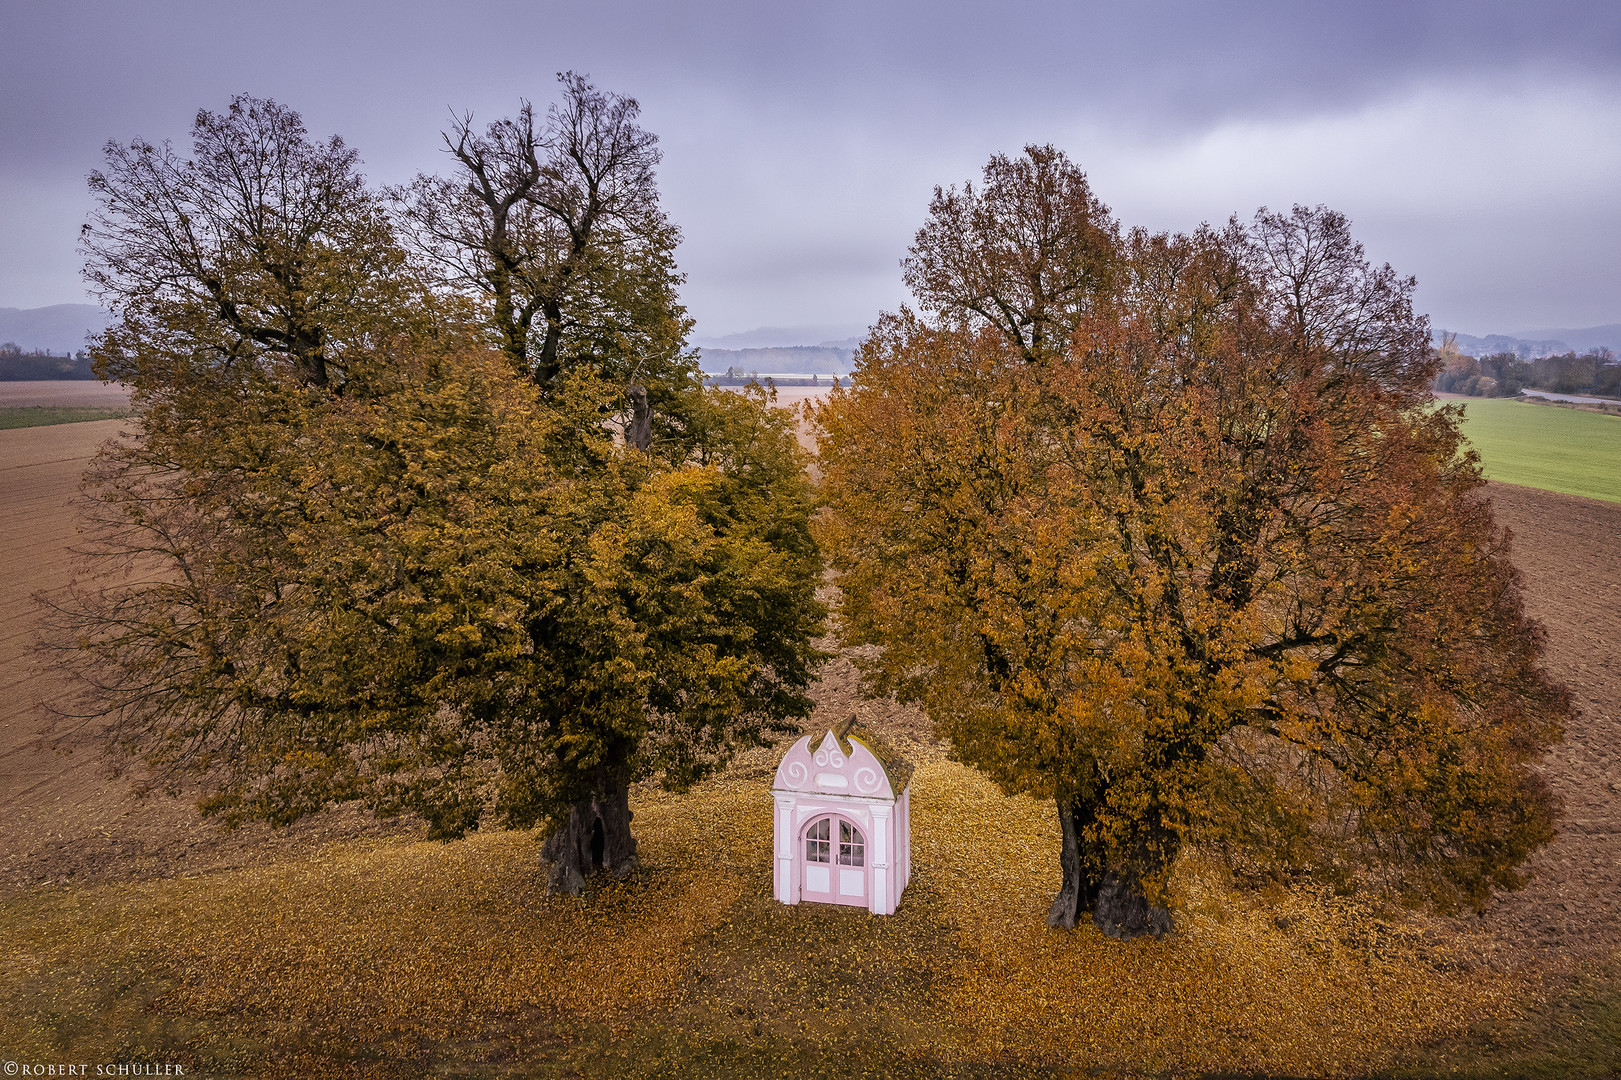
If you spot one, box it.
[772,717,913,915]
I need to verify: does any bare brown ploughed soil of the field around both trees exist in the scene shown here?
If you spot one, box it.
[0,415,1621,975]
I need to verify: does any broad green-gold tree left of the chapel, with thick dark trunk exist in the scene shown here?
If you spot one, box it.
[58,90,822,890]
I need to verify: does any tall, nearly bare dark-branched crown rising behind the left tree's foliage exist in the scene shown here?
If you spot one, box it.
[391,71,699,449]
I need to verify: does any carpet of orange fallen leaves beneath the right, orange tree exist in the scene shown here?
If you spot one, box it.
[913,761,1520,1075]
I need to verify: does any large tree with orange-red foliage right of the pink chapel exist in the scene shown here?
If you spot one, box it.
[817,148,1569,936]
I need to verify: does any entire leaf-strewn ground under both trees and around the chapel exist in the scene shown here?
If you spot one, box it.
[0,713,1595,1077]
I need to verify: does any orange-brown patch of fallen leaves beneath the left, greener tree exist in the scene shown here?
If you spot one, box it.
[162,834,736,1036]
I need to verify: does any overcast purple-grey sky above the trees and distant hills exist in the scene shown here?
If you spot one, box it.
[0,0,1621,344]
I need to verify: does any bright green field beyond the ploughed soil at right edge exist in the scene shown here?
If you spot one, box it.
[1448,397,1621,503]
